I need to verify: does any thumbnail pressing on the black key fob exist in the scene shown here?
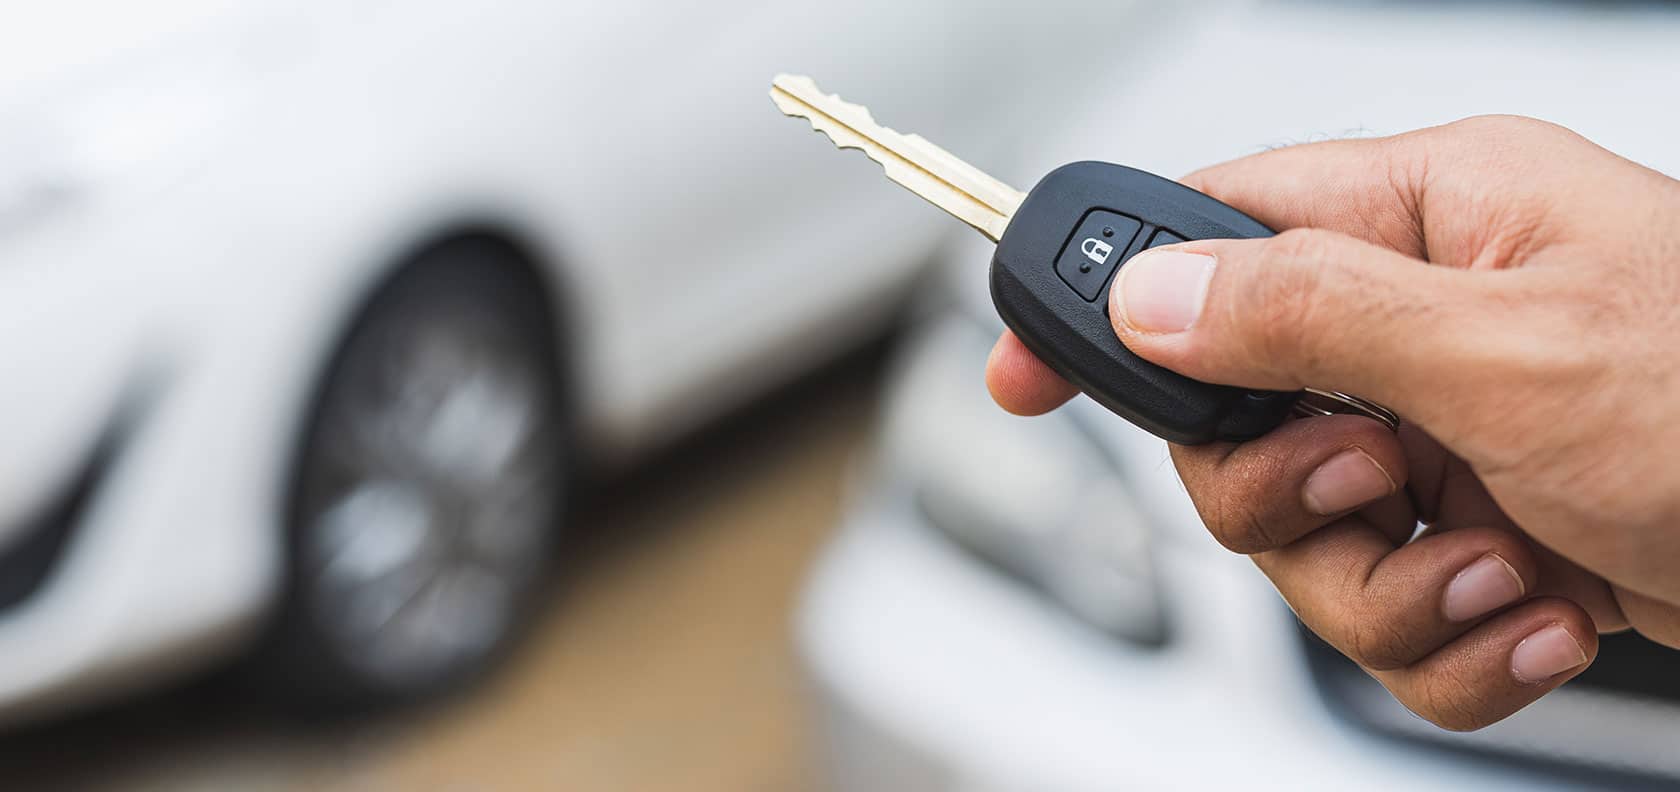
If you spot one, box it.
[1109,251,1213,333]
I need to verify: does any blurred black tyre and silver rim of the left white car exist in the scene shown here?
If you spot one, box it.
[274,240,570,703]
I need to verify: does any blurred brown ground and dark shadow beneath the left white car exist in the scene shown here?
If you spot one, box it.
[0,353,880,792]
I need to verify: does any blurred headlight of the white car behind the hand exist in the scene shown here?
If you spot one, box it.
[882,319,1166,644]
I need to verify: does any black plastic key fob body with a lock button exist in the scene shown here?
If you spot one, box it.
[991,161,1302,444]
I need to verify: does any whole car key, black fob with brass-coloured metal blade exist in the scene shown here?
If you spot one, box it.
[769,74,1399,444]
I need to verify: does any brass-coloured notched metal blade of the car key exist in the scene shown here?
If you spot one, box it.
[769,74,1026,242]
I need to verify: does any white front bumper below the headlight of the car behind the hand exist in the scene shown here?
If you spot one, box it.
[798,503,1585,790]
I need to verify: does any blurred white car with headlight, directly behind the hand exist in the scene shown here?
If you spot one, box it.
[798,2,1680,792]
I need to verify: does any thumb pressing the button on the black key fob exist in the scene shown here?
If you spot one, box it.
[1109,229,1512,430]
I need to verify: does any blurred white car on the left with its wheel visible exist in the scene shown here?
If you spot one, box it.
[0,0,1149,721]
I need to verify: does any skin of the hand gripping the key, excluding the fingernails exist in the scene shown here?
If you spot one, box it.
[986,116,1680,730]
